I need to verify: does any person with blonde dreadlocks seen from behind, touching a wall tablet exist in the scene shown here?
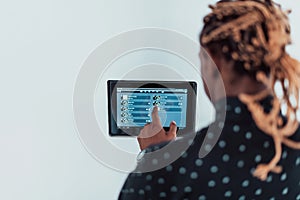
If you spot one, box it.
[119,0,300,200]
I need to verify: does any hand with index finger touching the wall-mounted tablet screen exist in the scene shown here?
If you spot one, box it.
[137,106,177,150]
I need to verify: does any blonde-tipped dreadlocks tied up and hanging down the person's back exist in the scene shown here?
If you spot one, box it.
[200,0,300,180]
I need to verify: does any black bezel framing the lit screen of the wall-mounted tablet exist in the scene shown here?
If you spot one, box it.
[107,80,197,136]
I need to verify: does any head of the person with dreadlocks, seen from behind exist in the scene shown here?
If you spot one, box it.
[199,0,300,108]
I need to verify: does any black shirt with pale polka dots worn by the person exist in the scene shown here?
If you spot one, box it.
[119,97,300,200]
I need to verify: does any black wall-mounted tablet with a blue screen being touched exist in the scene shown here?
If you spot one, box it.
[107,80,197,136]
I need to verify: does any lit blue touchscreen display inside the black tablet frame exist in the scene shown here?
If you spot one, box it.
[117,87,188,128]
